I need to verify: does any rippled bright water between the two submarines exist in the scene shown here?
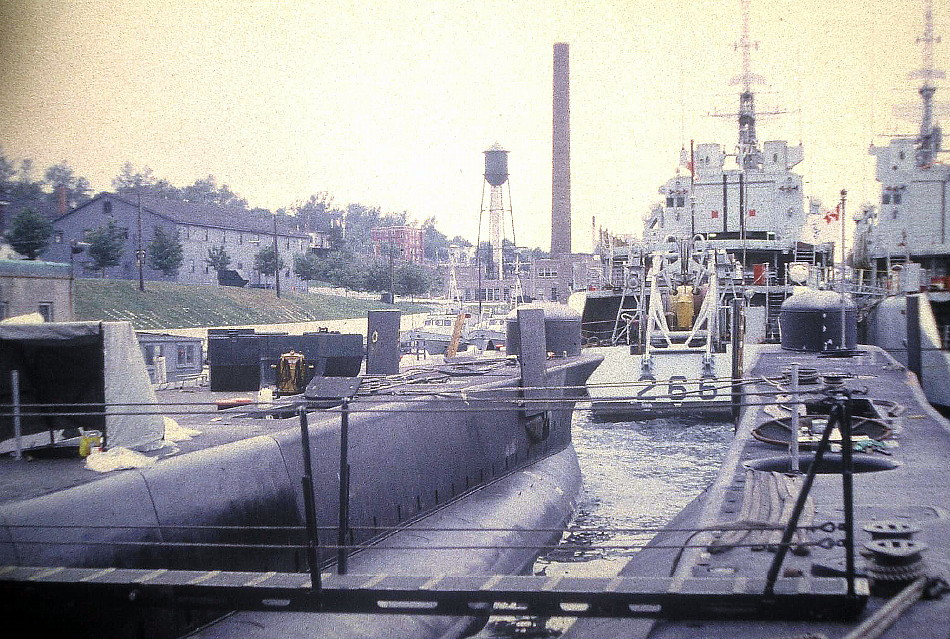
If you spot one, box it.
[477,410,733,639]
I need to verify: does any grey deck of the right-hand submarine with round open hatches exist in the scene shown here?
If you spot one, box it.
[564,345,950,639]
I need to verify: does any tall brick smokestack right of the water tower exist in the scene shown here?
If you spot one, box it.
[551,42,571,255]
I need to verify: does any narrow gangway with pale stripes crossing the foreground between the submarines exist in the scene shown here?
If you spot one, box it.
[0,566,867,619]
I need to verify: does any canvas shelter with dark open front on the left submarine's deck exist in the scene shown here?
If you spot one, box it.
[0,322,164,451]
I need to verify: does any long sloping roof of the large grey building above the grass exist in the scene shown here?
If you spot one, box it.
[69,193,309,238]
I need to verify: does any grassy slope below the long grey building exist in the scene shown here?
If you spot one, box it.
[75,279,429,329]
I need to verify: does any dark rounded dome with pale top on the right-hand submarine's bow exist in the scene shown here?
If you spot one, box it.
[779,289,858,352]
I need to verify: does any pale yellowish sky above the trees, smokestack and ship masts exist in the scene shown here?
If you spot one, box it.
[0,0,950,251]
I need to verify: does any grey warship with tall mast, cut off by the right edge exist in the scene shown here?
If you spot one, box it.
[855,3,950,409]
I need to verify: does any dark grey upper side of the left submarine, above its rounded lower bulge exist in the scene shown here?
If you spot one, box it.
[0,356,600,637]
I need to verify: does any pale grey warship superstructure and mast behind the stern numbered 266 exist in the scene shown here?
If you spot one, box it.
[577,3,831,344]
